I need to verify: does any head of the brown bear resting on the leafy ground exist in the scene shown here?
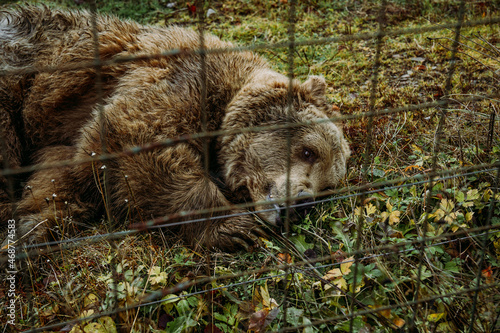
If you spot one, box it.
[218,71,350,225]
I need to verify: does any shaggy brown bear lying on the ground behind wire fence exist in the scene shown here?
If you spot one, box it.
[0,6,349,250]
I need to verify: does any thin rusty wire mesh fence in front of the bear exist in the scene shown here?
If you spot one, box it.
[0,0,500,332]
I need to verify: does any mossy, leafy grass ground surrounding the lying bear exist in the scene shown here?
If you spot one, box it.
[0,0,500,333]
